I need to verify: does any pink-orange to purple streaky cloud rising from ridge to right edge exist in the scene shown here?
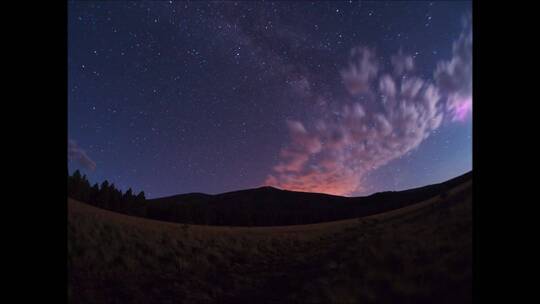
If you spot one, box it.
[265,19,472,195]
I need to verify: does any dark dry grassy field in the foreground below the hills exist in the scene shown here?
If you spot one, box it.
[68,180,472,303]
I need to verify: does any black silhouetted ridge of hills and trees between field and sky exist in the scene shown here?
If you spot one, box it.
[68,171,472,226]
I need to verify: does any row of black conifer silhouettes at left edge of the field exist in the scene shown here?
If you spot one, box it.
[68,170,146,217]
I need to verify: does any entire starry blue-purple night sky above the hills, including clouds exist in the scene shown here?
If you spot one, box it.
[67,1,472,198]
